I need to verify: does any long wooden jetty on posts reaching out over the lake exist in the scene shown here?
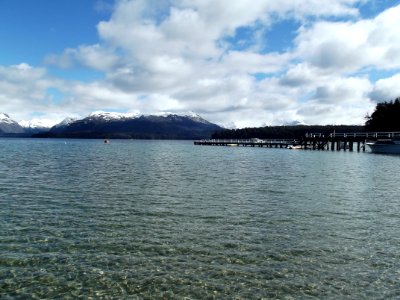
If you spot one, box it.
[194,132,400,152]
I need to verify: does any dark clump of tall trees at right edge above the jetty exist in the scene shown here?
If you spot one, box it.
[365,98,400,131]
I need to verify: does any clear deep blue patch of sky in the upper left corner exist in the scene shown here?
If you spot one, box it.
[0,0,103,65]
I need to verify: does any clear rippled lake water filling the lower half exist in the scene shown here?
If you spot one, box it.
[0,139,400,299]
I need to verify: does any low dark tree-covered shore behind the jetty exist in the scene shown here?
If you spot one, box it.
[212,125,364,139]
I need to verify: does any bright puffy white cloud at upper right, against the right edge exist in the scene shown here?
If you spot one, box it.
[296,5,400,72]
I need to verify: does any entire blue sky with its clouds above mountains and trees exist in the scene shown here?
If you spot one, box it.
[0,0,400,128]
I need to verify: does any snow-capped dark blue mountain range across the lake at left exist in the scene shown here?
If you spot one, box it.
[0,112,223,139]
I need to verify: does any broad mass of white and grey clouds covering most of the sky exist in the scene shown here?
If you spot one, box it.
[0,0,400,127]
